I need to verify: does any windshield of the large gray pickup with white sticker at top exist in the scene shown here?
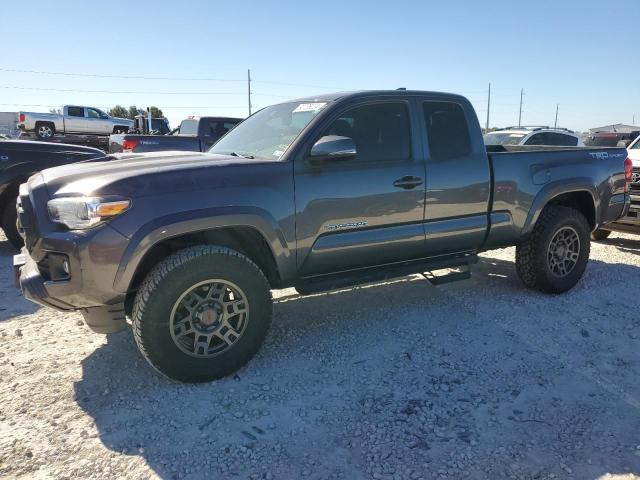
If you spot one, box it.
[209,102,326,160]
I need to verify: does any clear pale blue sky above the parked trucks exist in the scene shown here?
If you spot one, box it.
[0,0,640,130]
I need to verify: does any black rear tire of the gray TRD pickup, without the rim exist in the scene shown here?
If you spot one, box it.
[516,205,591,293]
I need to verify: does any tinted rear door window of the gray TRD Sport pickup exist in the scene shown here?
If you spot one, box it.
[422,101,471,161]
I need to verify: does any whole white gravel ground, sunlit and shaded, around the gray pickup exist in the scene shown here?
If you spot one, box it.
[0,234,640,480]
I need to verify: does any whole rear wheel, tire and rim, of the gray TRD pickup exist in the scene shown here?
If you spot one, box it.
[516,205,591,293]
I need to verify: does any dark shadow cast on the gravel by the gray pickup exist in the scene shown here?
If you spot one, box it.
[74,258,640,479]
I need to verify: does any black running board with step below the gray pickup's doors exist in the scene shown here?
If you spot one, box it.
[294,254,478,295]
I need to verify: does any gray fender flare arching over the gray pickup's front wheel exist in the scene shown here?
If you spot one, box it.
[113,207,296,293]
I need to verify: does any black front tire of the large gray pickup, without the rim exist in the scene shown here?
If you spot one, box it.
[132,245,273,382]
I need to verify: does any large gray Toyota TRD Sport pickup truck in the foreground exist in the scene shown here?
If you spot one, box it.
[14,91,631,382]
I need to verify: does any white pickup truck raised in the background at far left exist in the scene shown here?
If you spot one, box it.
[18,105,133,140]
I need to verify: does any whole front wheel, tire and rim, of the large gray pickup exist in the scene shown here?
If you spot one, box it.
[132,245,272,382]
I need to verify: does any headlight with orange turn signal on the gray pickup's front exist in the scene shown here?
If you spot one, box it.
[47,197,131,230]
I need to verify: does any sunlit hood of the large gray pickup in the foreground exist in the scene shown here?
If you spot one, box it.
[42,148,269,198]
